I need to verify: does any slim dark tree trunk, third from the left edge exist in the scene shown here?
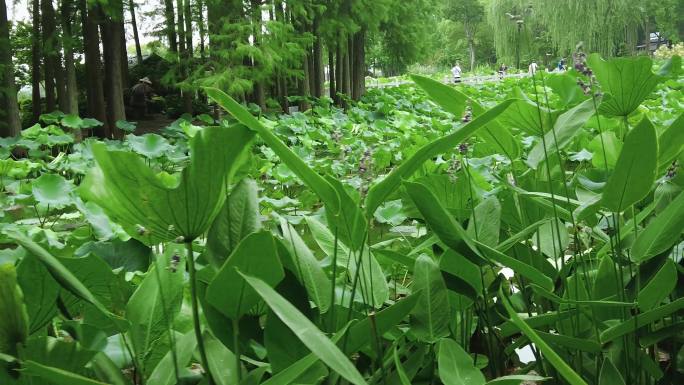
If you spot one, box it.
[40,0,57,113]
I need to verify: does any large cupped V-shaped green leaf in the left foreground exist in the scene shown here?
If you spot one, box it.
[79,126,254,244]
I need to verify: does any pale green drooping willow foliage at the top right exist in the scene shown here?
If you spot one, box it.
[488,0,645,60]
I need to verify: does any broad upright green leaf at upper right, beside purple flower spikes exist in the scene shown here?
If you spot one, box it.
[587,54,663,116]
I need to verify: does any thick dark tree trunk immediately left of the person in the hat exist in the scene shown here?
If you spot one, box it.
[102,0,126,138]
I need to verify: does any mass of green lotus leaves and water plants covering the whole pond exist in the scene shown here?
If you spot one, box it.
[0,55,684,385]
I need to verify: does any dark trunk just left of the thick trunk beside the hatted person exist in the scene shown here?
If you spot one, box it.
[79,0,110,138]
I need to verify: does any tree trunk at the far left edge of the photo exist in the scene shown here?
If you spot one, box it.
[0,0,21,137]
